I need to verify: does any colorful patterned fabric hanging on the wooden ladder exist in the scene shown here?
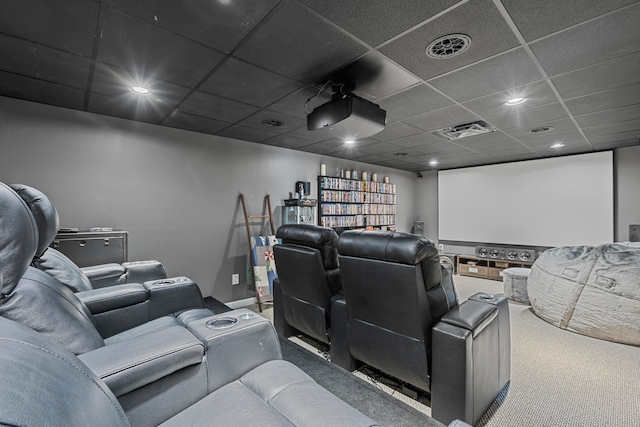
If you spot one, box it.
[251,236,282,301]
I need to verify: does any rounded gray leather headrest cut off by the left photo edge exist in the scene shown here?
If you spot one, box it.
[0,182,38,295]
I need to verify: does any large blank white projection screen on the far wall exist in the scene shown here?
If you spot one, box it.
[438,151,614,247]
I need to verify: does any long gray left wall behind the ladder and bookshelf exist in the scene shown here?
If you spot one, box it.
[0,97,416,302]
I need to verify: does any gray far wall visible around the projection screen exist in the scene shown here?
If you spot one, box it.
[416,146,640,254]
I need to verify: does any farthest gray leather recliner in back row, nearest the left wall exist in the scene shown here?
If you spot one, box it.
[9,184,167,292]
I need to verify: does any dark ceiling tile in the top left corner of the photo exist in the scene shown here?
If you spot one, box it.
[0,0,100,58]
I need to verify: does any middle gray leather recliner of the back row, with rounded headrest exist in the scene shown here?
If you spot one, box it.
[0,183,213,354]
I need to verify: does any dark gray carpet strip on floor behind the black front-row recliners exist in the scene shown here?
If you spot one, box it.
[280,338,443,427]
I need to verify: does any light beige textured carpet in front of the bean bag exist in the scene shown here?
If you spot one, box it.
[455,276,640,427]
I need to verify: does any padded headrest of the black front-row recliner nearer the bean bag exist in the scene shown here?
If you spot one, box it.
[338,230,442,289]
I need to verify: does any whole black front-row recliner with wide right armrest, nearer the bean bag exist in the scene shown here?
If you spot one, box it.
[331,230,510,424]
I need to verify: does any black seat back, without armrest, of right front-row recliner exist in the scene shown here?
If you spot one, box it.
[338,230,455,390]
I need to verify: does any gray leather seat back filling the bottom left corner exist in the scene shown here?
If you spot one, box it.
[0,318,129,427]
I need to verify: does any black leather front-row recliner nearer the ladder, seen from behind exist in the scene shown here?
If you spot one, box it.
[273,224,342,344]
